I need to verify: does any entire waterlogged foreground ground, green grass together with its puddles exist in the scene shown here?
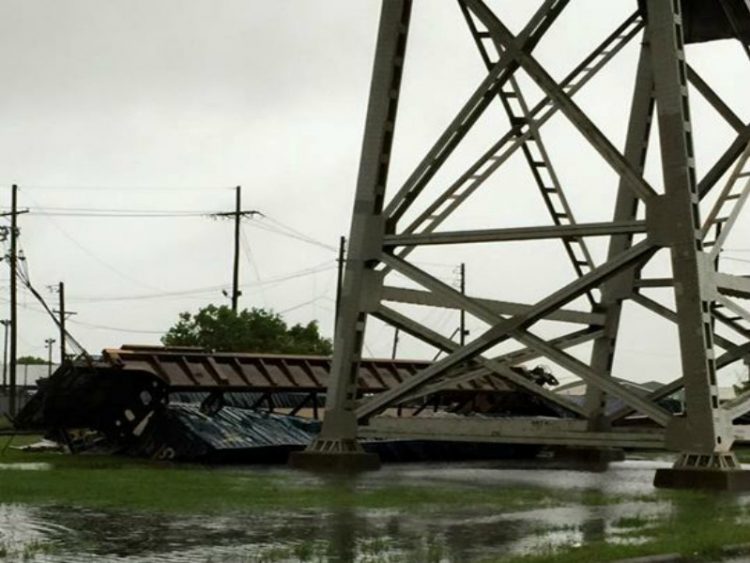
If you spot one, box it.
[0,436,750,563]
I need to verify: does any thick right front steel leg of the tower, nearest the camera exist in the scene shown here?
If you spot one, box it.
[648,0,733,456]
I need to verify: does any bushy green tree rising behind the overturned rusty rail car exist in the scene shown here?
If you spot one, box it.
[161,305,333,356]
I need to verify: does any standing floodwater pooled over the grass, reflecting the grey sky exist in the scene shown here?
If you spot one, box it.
[0,461,744,563]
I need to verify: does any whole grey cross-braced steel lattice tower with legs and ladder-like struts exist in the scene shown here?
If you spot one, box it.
[290,0,750,484]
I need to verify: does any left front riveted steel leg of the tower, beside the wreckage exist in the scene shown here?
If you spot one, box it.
[290,0,412,467]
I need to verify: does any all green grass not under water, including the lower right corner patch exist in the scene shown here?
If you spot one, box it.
[0,436,750,563]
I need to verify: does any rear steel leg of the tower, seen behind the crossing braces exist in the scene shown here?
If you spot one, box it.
[586,42,654,430]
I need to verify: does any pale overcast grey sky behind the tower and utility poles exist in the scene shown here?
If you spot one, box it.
[0,0,750,388]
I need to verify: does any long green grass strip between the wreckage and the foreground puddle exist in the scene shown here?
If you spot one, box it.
[0,436,636,512]
